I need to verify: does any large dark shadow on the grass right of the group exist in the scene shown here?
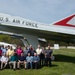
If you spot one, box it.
[54,54,75,63]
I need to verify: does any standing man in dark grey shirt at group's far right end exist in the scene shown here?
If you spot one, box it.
[44,46,53,67]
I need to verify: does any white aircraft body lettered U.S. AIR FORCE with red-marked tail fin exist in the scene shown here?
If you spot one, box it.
[0,14,75,42]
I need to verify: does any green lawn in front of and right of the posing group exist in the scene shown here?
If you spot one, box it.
[0,49,75,75]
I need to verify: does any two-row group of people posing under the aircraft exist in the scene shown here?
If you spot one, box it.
[0,45,53,70]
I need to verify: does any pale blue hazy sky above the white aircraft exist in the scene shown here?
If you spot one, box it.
[0,0,75,24]
